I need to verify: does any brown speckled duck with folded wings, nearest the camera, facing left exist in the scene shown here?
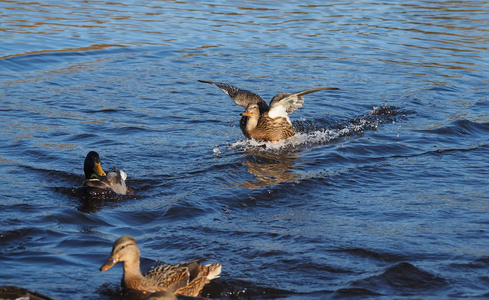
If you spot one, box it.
[100,235,221,297]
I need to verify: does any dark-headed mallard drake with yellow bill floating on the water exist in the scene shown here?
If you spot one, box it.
[83,151,130,195]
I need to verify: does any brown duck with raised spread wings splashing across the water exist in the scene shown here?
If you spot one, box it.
[199,80,339,142]
